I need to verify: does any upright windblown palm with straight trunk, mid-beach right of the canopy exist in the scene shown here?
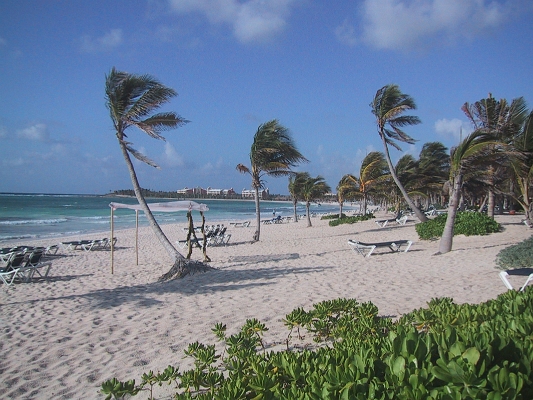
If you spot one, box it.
[237,119,307,242]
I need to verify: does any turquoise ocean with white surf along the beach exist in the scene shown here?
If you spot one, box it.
[0,193,349,242]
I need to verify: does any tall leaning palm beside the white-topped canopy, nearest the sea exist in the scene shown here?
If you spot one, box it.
[105,68,204,279]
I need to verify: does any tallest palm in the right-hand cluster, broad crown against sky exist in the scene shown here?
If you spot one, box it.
[461,93,527,217]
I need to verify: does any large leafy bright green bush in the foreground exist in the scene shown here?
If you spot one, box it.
[100,287,533,400]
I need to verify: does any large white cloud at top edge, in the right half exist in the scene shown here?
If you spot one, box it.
[337,0,517,50]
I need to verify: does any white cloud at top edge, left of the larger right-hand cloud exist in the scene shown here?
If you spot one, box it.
[169,0,296,43]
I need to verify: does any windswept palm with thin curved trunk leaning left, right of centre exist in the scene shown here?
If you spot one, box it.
[370,84,427,222]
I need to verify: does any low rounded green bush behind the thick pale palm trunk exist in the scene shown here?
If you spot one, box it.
[415,211,501,240]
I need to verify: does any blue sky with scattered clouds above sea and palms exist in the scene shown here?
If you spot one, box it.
[0,0,533,194]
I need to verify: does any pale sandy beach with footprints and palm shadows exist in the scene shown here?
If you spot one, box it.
[0,211,532,399]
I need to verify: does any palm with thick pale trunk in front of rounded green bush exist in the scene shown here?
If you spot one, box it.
[437,130,500,254]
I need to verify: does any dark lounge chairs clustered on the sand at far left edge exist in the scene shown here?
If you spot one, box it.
[0,247,52,287]
